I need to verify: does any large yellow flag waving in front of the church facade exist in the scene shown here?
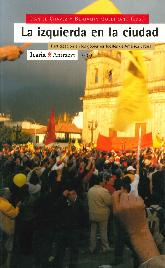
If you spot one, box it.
[114,51,151,131]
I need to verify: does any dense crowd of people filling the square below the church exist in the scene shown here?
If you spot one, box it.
[0,145,165,268]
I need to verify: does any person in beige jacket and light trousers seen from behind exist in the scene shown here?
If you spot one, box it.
[87,175,112,253]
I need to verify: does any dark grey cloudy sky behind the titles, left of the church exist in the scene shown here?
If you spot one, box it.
[0,0,165,123]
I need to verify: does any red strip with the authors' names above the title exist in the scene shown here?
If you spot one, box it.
[26,14,149,24]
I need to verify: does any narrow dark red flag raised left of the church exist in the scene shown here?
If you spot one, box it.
[44,110,56,145]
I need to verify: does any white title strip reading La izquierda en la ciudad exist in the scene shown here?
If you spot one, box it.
[14,23,165,43]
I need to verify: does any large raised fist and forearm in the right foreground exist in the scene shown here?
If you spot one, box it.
[112,191,160,267]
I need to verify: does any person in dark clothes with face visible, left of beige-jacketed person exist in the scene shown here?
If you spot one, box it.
[55,186,85,268]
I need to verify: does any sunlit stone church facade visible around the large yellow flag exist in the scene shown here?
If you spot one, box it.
[82,44,165,143]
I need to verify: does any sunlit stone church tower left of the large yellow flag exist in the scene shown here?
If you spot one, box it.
[83,50,122,142]
